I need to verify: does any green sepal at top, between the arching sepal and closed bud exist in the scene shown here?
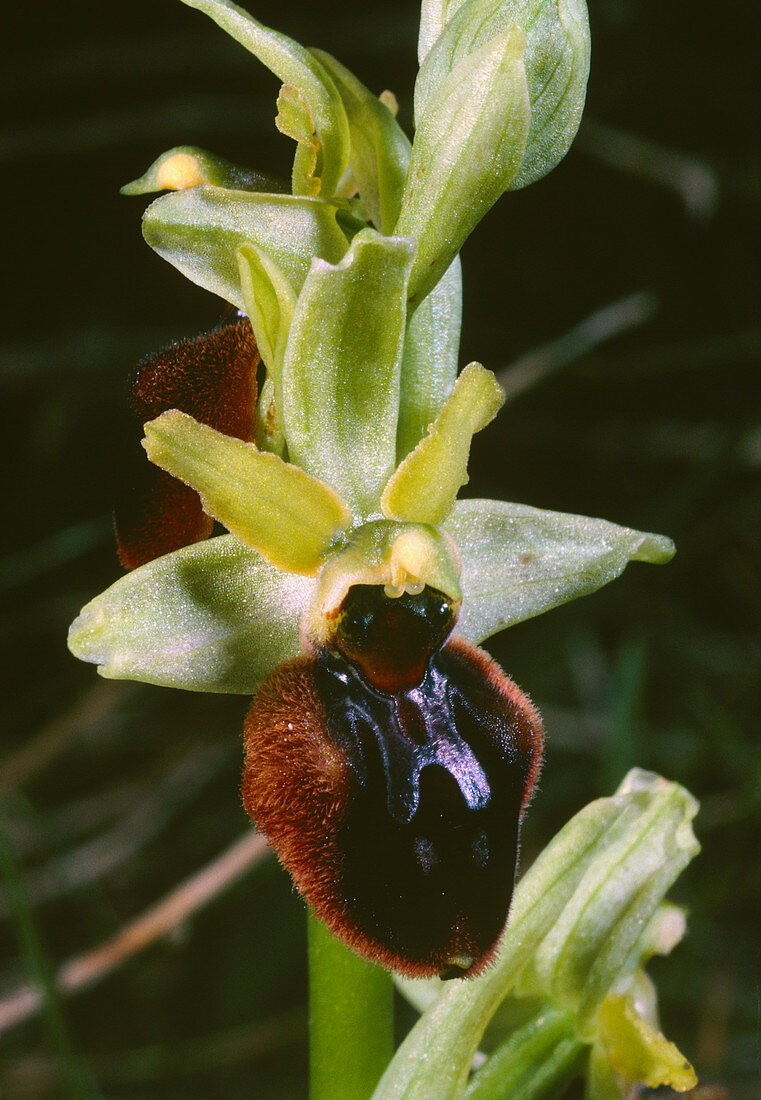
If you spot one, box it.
[310,50,410,233]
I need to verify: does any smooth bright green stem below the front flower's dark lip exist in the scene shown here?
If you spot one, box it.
[309,914,394,1100]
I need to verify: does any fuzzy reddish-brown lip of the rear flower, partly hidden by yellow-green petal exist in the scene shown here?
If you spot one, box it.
[114,316,258,569]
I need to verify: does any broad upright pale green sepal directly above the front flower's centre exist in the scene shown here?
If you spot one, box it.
[283,229,415,517]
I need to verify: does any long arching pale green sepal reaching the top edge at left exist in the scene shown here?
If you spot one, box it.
[183,0,350,198]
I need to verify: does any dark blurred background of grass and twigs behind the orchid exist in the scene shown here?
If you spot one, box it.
[0,0,761,1100]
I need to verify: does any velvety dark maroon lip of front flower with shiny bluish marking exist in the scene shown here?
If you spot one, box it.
[243,586,541,977]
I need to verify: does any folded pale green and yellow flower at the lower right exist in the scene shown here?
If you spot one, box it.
[382,769,699,1100]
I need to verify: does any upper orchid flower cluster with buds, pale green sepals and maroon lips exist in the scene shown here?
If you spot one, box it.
[70,0,694,1091]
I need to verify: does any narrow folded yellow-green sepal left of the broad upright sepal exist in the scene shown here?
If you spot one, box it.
[236,244,296,453]
